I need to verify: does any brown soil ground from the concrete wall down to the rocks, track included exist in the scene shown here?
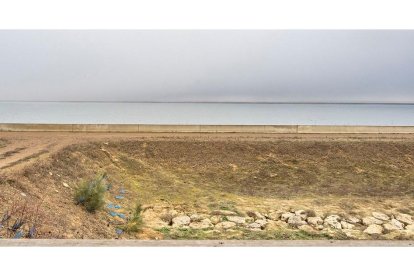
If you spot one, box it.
[0,132,414,239]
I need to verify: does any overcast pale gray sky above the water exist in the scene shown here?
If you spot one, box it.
[0,30,414,102]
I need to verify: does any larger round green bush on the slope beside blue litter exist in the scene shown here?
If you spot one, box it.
[75,174,107,212]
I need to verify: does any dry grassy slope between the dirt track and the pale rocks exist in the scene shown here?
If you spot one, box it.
[0,140,414,238]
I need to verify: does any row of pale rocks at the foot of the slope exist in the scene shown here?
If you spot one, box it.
[155,210,414,238]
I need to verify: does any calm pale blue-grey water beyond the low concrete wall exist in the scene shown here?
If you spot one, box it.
[0,102,414,126]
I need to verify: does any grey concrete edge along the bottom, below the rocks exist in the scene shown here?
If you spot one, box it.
[0,239,414,247]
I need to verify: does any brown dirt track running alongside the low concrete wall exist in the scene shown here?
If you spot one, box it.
[0,132,414,172]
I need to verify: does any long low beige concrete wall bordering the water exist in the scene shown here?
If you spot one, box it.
[0,123,414,134]
